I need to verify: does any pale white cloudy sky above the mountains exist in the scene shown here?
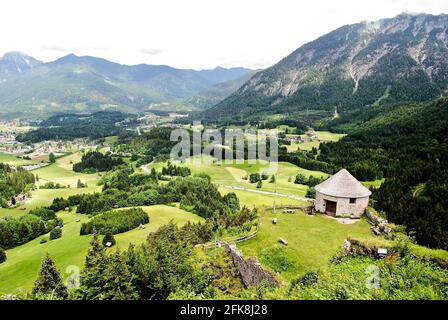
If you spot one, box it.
[0,0,448,69]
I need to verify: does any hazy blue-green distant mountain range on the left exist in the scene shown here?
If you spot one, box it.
[0,52,252,117]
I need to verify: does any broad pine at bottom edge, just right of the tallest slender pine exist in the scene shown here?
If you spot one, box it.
[102,250,138,300]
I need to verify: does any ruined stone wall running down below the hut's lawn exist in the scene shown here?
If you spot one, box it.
[224,242,279,287]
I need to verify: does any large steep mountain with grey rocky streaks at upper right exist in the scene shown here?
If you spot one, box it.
[204,14,448,119]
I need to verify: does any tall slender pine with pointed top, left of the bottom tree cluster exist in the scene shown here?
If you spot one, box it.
[79,233,107,300]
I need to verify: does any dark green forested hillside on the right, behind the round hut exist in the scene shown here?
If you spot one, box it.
[317,98,448,249]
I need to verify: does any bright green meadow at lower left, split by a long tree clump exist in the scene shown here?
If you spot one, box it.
[0,205,203,293]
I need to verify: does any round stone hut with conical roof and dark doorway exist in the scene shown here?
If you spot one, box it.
[314,169,372,218]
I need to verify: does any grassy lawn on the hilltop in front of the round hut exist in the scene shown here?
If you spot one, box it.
[238,211,375,280]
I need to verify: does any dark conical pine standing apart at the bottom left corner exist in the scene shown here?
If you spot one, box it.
[32,253,68,299]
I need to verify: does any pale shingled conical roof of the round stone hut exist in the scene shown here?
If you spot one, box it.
[315,169,372,198]
